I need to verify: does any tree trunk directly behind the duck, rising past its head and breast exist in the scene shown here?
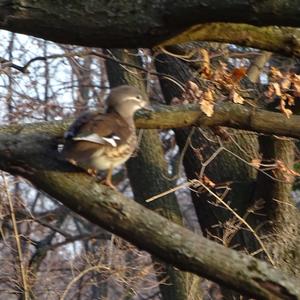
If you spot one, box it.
[106,49,202,300]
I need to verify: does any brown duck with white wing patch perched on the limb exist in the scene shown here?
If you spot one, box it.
[62,85,147,187]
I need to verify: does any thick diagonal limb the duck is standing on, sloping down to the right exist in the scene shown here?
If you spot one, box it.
[0,123,300,299]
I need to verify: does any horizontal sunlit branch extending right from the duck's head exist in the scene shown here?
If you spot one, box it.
[136,102,300,138]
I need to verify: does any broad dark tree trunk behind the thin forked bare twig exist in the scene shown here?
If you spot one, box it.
[156,49,257,248]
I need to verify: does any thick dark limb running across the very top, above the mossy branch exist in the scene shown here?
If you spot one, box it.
[0,0,300,48]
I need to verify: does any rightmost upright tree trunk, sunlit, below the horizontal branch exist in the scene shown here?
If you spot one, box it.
[255,136,300,276]
